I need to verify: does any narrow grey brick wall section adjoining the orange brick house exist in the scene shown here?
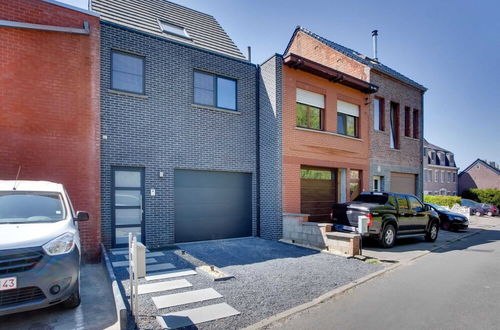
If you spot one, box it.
[259,55,283,239]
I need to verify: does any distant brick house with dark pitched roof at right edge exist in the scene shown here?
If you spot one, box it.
[458,159,500,194]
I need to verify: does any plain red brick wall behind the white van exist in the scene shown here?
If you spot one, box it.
[0,0,101,260]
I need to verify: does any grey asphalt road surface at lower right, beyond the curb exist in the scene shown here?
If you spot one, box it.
[271,226,500,330]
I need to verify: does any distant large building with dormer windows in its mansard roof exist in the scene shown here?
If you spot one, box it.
[424,140,458,196]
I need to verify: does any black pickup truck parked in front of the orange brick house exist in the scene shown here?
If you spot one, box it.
[332,192,439,248]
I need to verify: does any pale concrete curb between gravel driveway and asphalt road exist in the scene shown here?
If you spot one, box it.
[243,228,484,330]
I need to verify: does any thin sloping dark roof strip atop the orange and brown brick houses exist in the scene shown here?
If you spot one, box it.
[292,26,427,91]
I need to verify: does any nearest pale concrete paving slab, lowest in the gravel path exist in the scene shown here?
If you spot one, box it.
[156,303,240,329]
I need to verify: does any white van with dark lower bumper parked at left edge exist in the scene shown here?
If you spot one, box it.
[0,180,89,316]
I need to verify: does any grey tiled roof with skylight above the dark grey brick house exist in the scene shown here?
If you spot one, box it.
[91,0,245,60]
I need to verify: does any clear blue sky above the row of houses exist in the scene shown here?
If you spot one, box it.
[62,0,500,169]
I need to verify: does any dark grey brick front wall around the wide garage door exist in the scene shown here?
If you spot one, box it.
[101,23,260,247]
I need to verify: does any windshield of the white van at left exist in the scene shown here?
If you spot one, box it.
[0,191,66,224]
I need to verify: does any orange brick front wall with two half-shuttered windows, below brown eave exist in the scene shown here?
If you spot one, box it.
[283,66,369,213]
